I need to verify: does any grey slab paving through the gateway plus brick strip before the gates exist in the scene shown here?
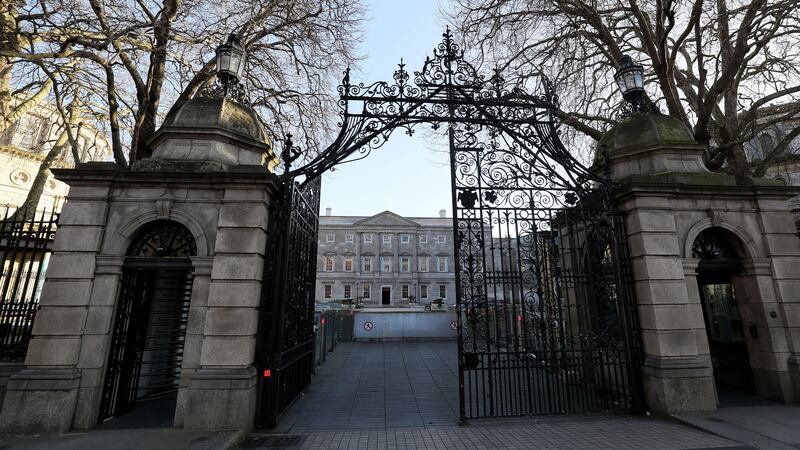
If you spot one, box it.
[258,341,744,449]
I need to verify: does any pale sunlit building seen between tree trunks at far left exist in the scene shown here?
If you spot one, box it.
[0,105,111,209]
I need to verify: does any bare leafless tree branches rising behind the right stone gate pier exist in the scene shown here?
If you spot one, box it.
[448,0,800,183]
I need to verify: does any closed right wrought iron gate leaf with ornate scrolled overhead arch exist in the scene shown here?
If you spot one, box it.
[274,31,642,421]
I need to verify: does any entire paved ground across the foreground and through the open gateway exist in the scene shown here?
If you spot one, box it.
[0,341,800,450]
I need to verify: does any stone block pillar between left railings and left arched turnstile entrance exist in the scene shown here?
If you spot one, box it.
[0,181,115,434]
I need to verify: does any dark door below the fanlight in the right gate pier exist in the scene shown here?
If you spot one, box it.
[698,274,755,391]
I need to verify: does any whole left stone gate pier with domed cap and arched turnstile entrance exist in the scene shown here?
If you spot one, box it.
[0,98,279,434]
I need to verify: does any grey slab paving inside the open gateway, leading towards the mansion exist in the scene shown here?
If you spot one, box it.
[278,341,458,433]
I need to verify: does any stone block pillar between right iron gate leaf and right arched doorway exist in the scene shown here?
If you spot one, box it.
[621,196,717,414]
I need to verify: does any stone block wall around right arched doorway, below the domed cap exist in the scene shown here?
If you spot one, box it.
[618,174,800,413]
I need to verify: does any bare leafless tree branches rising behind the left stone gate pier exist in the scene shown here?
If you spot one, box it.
[0,0,363,210]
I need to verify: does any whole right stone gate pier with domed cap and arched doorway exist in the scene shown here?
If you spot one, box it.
[595,113,800,414]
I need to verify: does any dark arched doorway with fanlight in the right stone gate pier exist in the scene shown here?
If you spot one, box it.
[692,227,755,393]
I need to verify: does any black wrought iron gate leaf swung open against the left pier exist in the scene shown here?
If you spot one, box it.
[257,177,321,428]
